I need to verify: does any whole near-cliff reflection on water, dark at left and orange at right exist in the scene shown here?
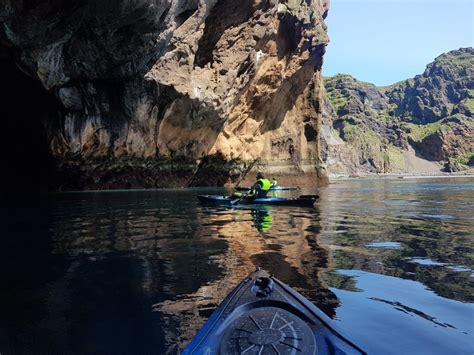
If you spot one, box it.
[39,192,338,353]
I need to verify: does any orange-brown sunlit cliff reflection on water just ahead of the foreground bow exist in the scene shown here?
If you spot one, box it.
[155,206,338,354]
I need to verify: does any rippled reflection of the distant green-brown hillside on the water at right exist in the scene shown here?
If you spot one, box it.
[319,179,474,302]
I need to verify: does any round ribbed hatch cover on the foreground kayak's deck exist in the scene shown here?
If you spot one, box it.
[220,307,316,355]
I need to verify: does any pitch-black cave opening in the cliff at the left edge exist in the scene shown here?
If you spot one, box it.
[0,57,60,192]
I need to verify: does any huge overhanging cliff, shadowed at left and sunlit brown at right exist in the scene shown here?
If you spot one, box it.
[0,0,328,187]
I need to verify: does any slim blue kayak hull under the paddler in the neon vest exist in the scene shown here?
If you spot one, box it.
[198,195,319,206]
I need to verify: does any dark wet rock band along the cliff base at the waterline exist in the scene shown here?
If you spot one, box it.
[53,155,250,190]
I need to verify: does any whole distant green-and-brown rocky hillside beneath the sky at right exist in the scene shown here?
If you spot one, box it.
[321,48,474,174]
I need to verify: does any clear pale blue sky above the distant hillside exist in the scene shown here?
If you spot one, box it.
[323,0,474,85]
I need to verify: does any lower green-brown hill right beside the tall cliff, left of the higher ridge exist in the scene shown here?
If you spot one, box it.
[322,74,408,175]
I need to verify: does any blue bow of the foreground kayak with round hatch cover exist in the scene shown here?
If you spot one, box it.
[183,269,366,355]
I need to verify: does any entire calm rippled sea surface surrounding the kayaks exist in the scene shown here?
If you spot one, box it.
[0,179,474,355]
